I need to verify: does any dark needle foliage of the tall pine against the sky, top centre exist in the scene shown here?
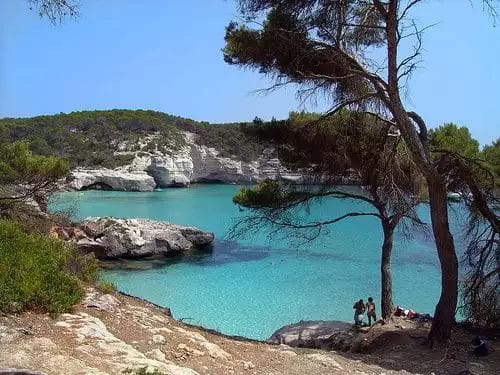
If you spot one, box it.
[223,0,378,99]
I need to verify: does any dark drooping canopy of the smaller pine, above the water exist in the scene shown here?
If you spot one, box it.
[249,110,423,200]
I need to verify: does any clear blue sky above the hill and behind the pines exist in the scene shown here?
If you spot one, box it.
[0,0,500,144]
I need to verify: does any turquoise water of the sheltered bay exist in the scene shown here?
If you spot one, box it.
[51,185,463,339]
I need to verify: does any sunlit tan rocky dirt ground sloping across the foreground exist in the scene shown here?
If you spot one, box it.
[0,290,500,375]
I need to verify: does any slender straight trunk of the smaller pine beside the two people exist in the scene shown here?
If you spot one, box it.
[380,222,394,319]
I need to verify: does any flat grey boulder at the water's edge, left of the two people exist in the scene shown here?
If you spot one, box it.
[268,320,352,349]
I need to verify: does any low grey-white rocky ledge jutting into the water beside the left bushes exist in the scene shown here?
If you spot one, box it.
[59,217,214,259]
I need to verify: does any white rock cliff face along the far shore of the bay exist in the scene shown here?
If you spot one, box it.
[64,132,304,191]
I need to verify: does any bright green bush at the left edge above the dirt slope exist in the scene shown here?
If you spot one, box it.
[0,220,98,313]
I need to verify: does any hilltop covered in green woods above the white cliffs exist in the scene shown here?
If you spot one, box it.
[0,109,265,168]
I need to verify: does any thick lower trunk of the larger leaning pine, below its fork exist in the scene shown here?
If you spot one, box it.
[427,176,458,345]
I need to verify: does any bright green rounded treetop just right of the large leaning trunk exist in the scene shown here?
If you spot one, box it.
[429,123,479,158]
